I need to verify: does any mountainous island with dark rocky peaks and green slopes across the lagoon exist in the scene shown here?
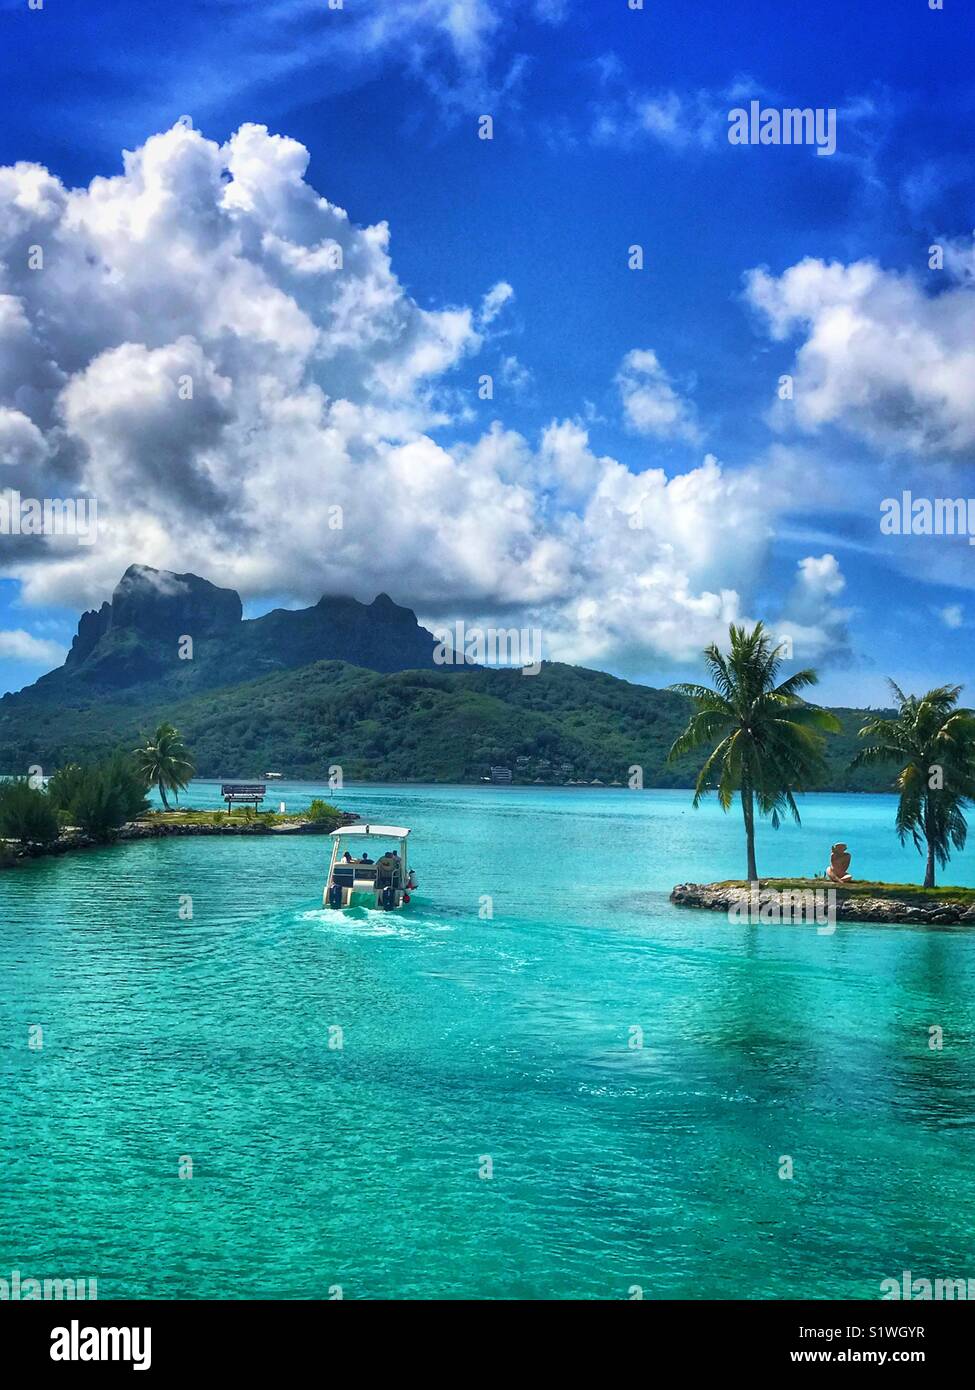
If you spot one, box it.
[0,566,890,791]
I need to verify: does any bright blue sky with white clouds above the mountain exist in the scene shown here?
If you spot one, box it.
[0,0,975,703]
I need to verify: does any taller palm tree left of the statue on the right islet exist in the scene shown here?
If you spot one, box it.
[668,623,840,883]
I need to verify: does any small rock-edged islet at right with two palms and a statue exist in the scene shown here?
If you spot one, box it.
[669,623,975,929]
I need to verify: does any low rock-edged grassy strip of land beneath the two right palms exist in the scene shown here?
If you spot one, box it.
[670,878,975,927]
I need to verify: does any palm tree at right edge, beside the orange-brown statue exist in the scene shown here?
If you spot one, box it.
[850,681,975,888]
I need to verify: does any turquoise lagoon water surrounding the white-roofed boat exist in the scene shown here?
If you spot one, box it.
[0,783,975,1298]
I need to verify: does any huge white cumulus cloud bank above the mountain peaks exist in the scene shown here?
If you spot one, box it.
[0,118,832,671]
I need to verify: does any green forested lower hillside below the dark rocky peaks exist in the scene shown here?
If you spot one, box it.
[0,662,893,791]
